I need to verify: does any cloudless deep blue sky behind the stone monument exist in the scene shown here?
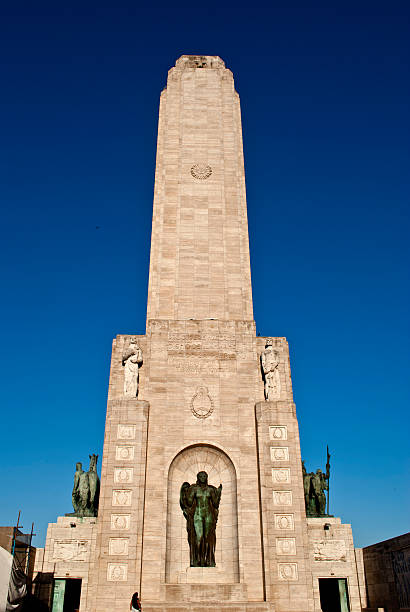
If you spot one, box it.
[0,0,410,546]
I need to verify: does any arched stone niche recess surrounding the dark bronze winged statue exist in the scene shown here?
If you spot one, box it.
[165,444,239,584]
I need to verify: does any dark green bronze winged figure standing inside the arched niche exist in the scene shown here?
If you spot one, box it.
[179,472,222,567]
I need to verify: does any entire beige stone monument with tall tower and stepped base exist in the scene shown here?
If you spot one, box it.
[37,56,361,612]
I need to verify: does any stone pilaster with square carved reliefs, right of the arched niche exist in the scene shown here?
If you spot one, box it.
[256,401,314,612]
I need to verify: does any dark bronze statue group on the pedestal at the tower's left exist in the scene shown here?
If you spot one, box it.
[66,454,100,516]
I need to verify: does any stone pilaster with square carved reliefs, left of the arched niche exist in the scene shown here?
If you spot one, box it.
[87,398,149,612]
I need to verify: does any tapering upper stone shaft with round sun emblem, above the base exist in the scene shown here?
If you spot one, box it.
[147,56,253,322]
